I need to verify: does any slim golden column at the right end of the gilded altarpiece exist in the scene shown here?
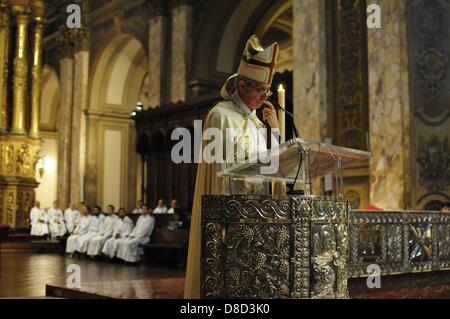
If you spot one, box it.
[29,1,45,138]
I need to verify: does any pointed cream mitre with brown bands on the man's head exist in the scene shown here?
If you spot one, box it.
[220,35,279,99]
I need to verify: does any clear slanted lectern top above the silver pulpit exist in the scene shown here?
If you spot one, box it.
[218,138,370,183]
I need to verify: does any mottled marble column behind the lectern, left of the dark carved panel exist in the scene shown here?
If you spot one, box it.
[292,0,327,194]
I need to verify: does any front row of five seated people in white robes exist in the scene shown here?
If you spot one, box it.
[66,205,155,263]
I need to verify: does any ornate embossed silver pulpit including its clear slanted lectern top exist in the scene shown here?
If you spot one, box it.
[201,139,370,298]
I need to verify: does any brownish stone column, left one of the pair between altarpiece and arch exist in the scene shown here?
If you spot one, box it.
[57,35,74,206]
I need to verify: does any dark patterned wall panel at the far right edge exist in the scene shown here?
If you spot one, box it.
[407,0,450,209]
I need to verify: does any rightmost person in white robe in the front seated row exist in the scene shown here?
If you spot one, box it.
[116,205,155,262]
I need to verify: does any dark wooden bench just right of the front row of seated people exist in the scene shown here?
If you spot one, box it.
[140,228,189,267]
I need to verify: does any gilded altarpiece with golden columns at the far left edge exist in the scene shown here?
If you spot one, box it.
[0,0,45,230]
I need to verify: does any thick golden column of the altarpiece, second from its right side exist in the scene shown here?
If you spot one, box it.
[11,5,30,134]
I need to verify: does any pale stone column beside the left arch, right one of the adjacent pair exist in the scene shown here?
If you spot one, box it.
[70,29,89,203]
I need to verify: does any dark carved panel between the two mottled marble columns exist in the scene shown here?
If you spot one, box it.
[327,0,368,150]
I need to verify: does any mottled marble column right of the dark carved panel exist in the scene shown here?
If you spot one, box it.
[368,0,410,210]
